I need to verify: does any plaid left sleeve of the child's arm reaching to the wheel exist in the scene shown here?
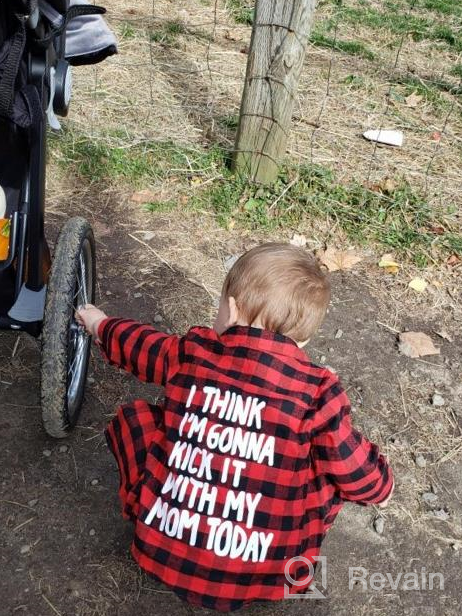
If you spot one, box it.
[96,317,180,386]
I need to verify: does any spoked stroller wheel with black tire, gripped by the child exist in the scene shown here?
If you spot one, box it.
[42,217,95,438]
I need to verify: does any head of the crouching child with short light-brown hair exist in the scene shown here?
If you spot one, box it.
[214,243,330,343]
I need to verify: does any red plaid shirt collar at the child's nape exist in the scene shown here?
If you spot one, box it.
[220,325,309,362]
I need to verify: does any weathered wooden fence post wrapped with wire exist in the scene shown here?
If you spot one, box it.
[233,0,316,184]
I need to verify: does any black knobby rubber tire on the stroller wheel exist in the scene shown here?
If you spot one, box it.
[41,217,96,438]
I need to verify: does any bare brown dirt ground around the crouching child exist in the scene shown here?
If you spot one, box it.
[0,189,462,616]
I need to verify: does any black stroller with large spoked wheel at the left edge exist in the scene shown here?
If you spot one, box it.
[0,0,117,437]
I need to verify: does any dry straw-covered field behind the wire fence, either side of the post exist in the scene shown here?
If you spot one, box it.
[62,0,462,262]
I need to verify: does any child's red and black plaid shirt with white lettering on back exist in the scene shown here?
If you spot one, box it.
[98,318,393,611]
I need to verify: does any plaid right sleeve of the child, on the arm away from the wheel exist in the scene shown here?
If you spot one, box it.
[312,378,393,505]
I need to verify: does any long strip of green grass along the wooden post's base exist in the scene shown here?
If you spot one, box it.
[52,131,462,266]
